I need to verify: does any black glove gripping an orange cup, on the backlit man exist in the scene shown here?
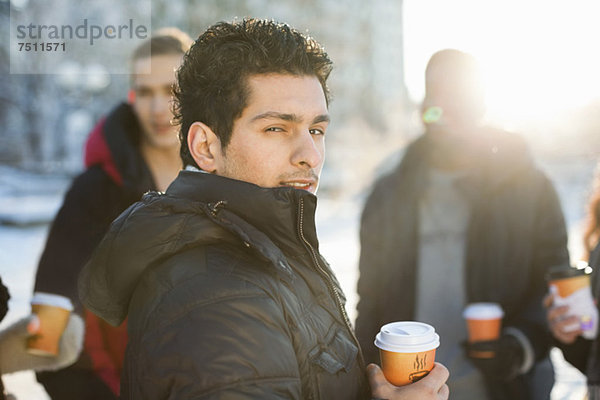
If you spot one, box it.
[465,334,525,382]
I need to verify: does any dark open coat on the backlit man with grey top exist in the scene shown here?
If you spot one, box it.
[356,129,569,400]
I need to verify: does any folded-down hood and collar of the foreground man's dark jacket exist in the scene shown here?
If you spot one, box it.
[79,171,318,325]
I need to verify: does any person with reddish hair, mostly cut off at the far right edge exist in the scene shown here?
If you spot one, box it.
[545,164,600,400]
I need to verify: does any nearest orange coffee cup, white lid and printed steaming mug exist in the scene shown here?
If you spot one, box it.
[375,321,440,386]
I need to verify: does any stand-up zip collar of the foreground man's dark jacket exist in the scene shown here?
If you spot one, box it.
[166,170,319,255]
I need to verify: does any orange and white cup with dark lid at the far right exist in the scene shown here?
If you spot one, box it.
[546,267,598,339]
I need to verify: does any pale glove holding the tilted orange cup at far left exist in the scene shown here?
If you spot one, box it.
[0,314,85,374]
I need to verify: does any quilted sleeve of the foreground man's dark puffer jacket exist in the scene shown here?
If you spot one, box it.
[129,270,303,400]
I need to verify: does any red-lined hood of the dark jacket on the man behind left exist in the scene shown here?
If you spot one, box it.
[85,103,155,193]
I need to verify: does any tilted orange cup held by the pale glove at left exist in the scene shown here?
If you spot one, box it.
[27,293,73,357]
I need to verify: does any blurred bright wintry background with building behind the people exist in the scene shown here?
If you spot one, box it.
[0,0,600,400]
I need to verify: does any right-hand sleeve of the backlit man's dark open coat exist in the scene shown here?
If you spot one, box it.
[513,176,569,368]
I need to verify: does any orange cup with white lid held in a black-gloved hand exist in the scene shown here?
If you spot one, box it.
[463,303,504,358]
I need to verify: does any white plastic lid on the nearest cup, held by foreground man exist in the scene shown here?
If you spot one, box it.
[375,321,440,353]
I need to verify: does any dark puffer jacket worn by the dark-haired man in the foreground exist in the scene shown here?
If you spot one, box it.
[80,171,368,399]
